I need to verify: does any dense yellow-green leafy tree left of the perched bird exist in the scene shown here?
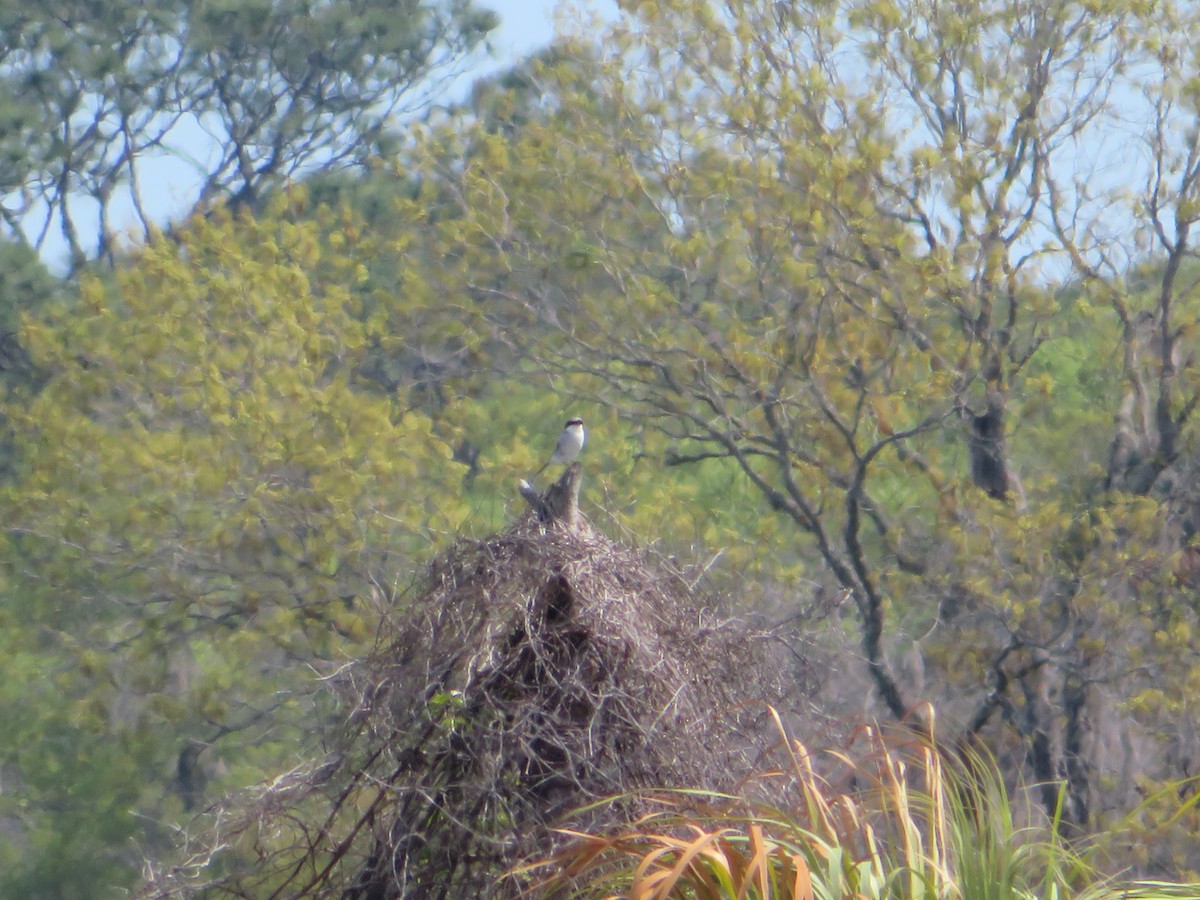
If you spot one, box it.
[0,202,466,893]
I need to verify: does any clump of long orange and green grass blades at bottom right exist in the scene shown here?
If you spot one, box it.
[521,716,1200,900]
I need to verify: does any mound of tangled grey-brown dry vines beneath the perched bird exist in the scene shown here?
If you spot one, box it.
[145,473,803,900]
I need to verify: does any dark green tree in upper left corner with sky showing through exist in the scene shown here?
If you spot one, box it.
[0,0,497,266]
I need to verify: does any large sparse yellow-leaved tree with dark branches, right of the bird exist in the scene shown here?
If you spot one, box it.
[412,2,1196,854]
